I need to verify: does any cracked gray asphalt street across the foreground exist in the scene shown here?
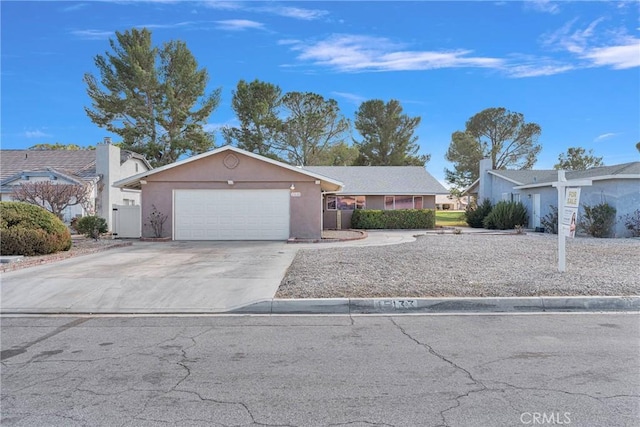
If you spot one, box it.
[0,313,640,426]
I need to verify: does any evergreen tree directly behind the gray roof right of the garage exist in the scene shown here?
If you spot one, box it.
[354,99,430,166]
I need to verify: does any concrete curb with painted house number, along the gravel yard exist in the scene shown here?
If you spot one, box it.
[227,296,640,314]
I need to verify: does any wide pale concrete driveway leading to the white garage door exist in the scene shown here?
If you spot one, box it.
[0,241,298,313]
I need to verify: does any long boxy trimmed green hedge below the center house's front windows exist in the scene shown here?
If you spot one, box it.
[351,209,436,230]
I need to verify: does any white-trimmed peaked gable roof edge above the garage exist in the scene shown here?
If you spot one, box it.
[113,145,343,190]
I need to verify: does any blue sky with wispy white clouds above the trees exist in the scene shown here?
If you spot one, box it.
[0,0,640,186]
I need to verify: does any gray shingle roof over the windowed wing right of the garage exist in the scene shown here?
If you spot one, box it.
[304,166,449,196]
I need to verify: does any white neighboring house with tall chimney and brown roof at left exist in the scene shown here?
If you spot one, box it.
[0,138,152,231]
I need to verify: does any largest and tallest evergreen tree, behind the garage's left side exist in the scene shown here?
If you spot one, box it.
[84,29,220,167]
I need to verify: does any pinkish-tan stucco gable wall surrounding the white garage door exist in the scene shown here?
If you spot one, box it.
[142,151,322,239]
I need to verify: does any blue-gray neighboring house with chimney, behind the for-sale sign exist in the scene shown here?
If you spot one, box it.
[465,159,640,237]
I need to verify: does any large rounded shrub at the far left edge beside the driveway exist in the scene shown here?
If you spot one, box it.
[0,202,71,256]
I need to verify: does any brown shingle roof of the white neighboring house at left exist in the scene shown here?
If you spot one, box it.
[0,150,151,182]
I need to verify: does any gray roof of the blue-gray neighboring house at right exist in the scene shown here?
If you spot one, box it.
[464,162,640,193]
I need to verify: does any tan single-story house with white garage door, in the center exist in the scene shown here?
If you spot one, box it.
[115,146,446,240]
